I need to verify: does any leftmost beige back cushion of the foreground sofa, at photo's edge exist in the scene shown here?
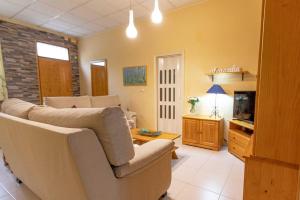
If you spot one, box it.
[1,98,36,119]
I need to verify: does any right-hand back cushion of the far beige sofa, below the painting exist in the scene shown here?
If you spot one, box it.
[90,95,121,108]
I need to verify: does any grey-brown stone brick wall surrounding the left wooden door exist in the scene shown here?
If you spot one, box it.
[0,20,80,103]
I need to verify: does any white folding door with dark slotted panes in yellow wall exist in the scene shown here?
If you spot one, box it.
[157,54,183,134]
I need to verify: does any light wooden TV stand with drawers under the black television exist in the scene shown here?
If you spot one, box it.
[228,120,254,161]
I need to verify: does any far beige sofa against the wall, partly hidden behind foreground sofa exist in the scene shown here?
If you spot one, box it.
[43,95,136,128]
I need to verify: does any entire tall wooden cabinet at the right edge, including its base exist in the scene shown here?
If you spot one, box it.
[244,0,300,200]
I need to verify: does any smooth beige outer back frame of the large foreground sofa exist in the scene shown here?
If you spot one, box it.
[0,113,114,200]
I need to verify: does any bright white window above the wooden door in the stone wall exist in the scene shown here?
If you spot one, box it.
[36,42,69,60]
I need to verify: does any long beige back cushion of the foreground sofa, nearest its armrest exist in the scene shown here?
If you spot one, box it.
[29,107,134,166]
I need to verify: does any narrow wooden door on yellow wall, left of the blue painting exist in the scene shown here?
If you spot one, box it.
[91,64,108,96]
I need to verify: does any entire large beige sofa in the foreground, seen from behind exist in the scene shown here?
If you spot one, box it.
[0,99,173,200]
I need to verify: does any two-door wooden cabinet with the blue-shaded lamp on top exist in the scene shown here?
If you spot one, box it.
[182,114,224,151]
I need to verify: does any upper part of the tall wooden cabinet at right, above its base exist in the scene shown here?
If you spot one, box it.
[254,0,300,164]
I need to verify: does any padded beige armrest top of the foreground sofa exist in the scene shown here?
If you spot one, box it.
[114,139,174,178]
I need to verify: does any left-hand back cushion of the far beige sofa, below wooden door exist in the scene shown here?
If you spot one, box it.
[44,96,91,108]
